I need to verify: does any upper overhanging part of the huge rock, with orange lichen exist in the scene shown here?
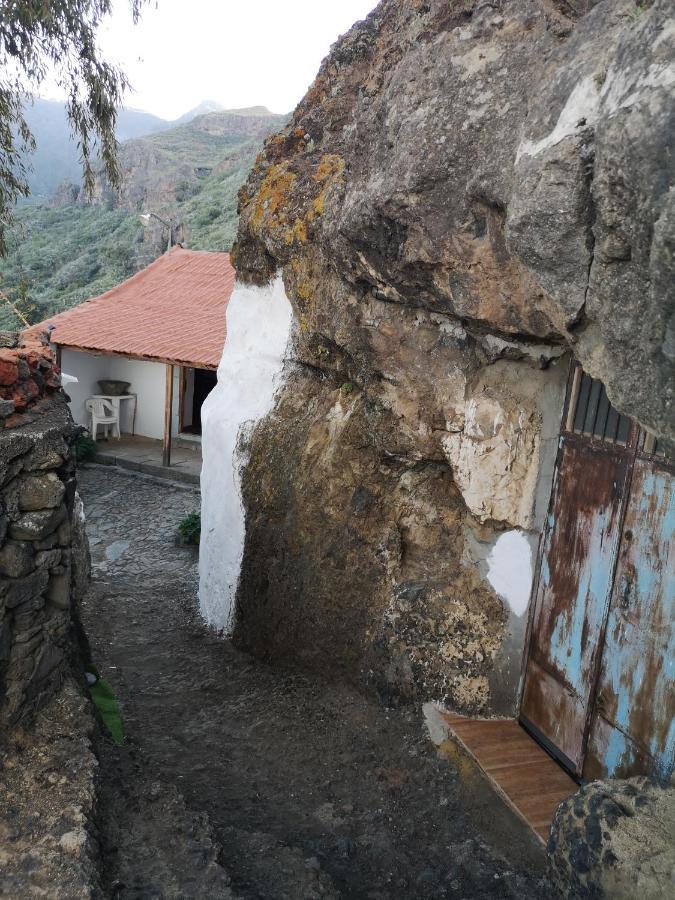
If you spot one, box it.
[236,0,675,438]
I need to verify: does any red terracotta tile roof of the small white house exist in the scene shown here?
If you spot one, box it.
[31,247,234,368]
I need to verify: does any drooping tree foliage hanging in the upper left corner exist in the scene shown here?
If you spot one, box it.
[0,0,146,255]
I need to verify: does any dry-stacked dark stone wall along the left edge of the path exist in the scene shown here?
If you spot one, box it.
[0,333,88,730]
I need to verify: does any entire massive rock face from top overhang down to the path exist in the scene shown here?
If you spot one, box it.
[227,0,675,710]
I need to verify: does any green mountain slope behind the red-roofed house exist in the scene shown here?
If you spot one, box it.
[0,107,285,328]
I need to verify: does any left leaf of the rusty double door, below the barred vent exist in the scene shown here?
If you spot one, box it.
[521,436,631,774]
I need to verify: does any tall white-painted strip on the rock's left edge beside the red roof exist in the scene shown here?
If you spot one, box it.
[199,276,293,633]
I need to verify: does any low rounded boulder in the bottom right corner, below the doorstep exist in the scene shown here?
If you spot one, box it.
[549,778,675,900]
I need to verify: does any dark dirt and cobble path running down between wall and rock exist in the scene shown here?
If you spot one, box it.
[81,467,549,900]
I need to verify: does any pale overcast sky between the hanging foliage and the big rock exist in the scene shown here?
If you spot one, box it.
[82,0,377,119]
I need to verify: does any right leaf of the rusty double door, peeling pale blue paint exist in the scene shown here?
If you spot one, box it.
[584,459,675,778]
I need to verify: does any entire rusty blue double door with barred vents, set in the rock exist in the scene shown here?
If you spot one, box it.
[520,366,675,780]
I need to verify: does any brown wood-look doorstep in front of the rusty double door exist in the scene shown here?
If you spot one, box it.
[440,712,579,843]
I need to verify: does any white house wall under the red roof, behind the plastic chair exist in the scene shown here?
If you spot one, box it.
[61,350,168,440]
